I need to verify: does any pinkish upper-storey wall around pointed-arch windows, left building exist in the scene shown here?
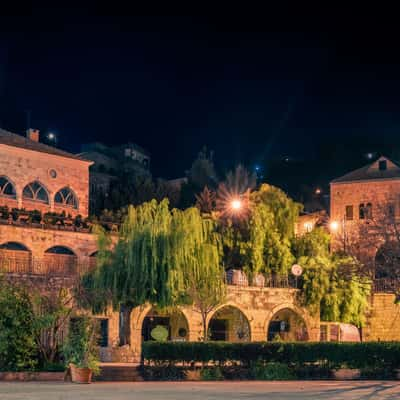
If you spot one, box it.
[0,145,90,217]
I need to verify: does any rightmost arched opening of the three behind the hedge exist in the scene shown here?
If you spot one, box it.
[267,308,308,342]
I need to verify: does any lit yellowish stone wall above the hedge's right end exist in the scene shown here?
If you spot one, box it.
[362,293,400,341]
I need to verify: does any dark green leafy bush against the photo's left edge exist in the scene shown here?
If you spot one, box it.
[0,279,37,371]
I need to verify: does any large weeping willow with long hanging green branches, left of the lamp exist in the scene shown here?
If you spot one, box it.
[83,200,225,340]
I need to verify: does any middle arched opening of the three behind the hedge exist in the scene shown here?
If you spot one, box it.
[208,306,251,342]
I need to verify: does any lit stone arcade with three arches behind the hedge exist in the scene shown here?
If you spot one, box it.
[97,286,319,362]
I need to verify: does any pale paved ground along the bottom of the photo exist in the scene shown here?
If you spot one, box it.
[0,381,400,400]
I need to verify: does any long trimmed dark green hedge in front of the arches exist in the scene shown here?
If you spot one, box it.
[142,341,400,369]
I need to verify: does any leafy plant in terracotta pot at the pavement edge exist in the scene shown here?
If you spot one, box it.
[63,316,100,383]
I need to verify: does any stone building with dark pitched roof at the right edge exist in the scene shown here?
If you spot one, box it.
[330,157,400,340]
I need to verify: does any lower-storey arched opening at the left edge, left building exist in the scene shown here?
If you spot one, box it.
[0,242,34,273]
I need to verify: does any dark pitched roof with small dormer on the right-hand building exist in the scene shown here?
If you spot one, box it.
[331,157,400,183]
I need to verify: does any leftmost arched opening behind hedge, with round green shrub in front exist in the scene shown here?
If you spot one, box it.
[142,308,189,342]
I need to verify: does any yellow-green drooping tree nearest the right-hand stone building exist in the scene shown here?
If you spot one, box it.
[294,229,371,327]
